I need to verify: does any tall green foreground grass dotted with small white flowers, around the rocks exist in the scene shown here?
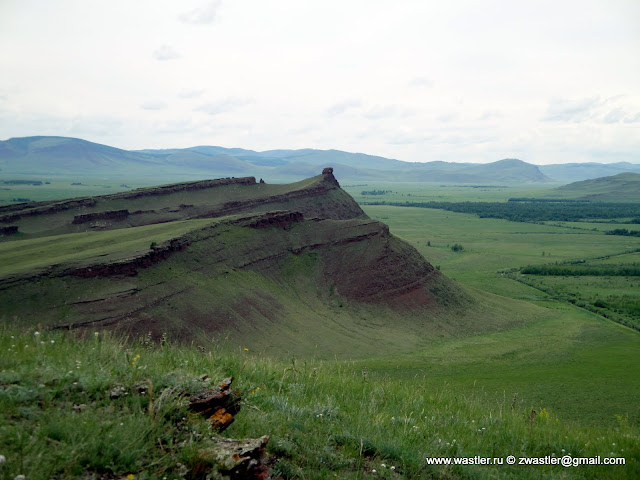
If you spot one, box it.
[0,329,640,480]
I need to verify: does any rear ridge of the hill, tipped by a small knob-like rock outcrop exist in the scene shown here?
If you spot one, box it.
[0,169,365,237]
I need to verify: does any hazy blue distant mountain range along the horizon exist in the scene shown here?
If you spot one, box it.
[0,136,640,185]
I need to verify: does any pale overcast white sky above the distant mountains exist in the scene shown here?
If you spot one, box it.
[0,0,640,165]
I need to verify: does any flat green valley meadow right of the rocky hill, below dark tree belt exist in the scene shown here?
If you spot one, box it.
[356,196,640,432]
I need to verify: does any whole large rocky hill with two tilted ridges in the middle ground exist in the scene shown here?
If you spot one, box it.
[0,169,524,357]
